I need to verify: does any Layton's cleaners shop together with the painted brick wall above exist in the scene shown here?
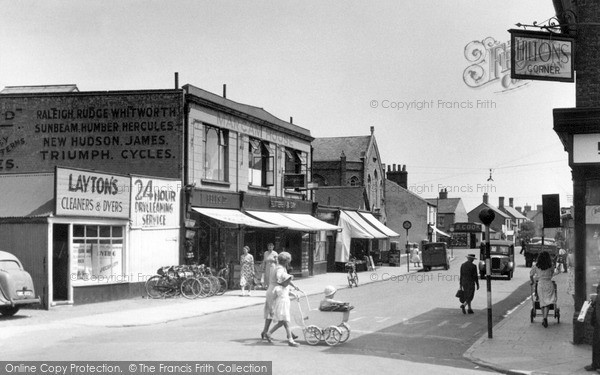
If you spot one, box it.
[0,89,184,307]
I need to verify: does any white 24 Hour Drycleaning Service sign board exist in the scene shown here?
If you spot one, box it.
[131,176,181,228]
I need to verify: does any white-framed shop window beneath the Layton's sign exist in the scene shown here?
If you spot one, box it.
[72,225,124,282]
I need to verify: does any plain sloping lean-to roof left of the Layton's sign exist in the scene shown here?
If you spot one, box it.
[0,172,54,218]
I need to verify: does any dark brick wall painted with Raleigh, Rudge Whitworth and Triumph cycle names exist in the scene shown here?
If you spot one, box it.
[0,90,183,178]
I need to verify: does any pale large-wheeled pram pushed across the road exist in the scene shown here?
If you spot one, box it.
[294,291,350,346]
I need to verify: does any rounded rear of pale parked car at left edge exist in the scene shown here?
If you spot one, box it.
[0,251,40,316]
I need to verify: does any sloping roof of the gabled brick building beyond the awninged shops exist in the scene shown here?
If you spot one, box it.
[312,135,371,161]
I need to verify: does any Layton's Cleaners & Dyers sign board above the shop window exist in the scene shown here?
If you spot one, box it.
[55,168,130,219]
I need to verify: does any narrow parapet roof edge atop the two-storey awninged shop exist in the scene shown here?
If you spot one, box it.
[183,84,313,141]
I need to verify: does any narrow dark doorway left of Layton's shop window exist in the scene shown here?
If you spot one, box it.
[52,224,69,301]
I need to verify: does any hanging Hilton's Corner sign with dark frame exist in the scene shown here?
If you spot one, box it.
[509,30,575,82]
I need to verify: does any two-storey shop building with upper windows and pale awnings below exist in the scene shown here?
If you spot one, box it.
[183,85,339,282]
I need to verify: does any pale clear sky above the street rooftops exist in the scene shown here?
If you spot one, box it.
[0,0,575,211]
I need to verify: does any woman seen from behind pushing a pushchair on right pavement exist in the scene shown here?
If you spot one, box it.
[529,251,559,328]
